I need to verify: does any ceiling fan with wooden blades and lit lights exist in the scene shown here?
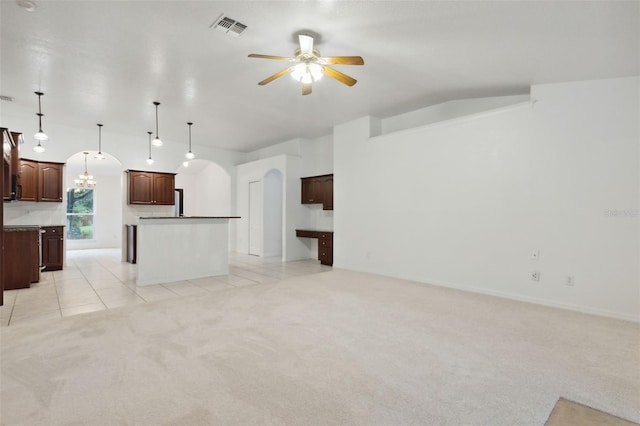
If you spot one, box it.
[249,34,364,95]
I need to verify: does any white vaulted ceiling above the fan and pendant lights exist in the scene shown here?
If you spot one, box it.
[0,0,640,152]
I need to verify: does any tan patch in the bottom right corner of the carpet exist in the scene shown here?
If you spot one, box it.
[545,398,638,426]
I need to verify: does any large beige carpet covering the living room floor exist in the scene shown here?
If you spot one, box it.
[0,270,640,426]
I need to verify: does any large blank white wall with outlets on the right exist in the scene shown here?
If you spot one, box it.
[334,78,640,321]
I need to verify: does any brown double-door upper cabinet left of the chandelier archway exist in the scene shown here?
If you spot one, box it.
[16,158,64,203]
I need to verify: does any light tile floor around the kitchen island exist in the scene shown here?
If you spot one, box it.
[0,249,331,327]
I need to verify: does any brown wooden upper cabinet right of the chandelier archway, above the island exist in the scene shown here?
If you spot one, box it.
[127,170,175,206]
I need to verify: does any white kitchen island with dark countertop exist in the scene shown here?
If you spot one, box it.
[136,216,239,286]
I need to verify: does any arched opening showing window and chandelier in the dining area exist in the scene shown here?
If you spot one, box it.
[65,151,123,250]
